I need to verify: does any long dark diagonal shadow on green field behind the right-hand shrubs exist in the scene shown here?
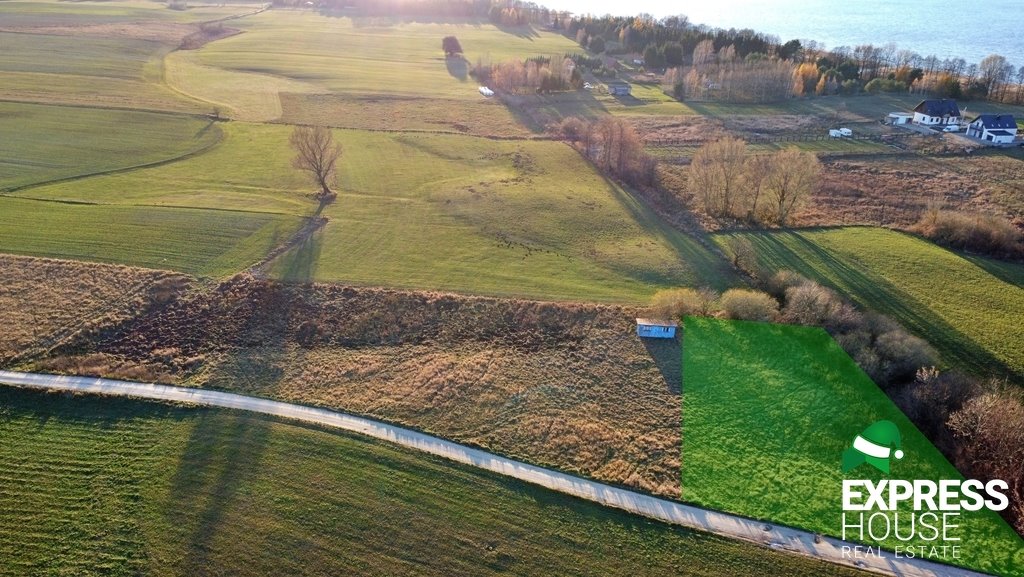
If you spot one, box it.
[752,232,1021,381]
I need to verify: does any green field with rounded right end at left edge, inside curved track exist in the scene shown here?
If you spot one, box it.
[0,102,221,191]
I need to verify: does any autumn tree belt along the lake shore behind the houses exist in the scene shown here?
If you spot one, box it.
[560,15,1024,104]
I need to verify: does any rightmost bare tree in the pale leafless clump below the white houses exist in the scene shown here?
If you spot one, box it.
[764,148,821,226]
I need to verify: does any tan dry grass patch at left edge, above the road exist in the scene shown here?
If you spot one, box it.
[0,255,186,366]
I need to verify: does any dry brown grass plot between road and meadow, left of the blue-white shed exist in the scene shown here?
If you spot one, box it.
[32,277,681,496]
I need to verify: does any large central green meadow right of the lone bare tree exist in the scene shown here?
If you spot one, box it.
[275,131,731,302]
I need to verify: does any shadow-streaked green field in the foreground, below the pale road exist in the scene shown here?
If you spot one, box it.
[0,387,872,576]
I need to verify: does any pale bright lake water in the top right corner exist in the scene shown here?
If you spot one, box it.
[541,0,1024,66]
